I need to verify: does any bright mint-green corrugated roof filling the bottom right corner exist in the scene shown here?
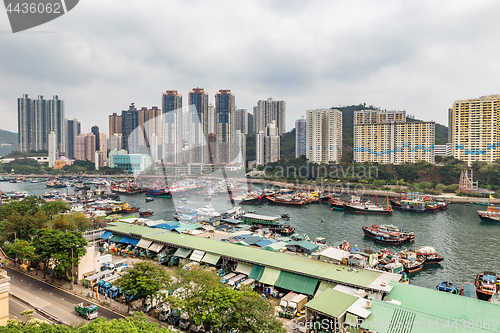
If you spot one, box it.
[385,282,500,322]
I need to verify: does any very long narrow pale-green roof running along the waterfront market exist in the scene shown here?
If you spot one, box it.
[105,222,383,289]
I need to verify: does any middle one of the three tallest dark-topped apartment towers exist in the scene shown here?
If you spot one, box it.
[187,88,209,163]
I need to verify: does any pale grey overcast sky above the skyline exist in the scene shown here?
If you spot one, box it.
[0,0,500,133]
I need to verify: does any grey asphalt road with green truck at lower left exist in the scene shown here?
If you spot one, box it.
[6,268,123,324]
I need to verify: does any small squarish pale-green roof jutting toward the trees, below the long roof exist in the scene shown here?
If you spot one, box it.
[306,289,358,320]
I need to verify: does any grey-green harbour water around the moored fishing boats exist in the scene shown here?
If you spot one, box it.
[0,182,500,288]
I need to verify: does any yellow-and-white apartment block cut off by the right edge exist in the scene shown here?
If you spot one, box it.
[449,95,500,165]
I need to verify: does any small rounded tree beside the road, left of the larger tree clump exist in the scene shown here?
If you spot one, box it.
[116,261,172,307]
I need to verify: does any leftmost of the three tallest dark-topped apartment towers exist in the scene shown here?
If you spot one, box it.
[162,90,183,164]
